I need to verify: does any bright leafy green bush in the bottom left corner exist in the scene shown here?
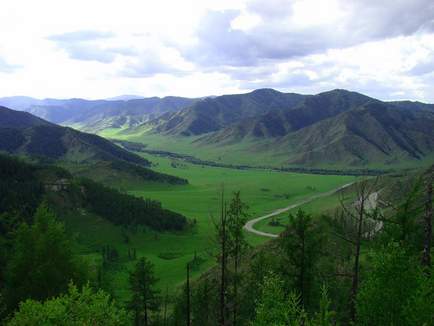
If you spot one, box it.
[6,283,129,326]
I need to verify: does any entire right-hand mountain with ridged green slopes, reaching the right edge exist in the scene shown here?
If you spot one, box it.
[193,90,434,168]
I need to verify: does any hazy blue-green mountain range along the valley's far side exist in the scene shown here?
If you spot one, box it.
[0,89,434,167]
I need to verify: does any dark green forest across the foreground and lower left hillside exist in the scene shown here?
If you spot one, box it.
[0,155,434,325]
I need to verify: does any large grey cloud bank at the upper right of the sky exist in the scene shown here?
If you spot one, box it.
[178,0,434,70]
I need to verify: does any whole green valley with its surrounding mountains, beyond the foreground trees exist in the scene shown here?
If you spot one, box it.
[0,89,434,325]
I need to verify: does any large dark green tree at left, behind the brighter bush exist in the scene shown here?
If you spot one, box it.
[5,204,87,311]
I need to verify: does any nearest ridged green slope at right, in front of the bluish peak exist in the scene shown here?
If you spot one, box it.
[249,101,434,166]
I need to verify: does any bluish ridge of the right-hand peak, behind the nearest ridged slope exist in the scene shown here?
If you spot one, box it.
[197,89,374,145]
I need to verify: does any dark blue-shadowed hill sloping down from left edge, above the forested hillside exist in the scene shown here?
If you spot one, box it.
[0,107,150,166]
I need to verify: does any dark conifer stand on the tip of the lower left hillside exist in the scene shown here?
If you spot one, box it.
[80,178,187,231]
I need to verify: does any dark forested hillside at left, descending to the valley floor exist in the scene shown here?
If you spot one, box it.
[0,154,189,317]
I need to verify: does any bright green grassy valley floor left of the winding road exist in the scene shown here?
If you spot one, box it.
[59,154,354,302]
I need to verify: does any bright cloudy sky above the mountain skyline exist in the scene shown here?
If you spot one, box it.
[0,0,434,103]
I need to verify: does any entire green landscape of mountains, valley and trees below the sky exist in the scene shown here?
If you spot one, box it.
[0,89,434,326]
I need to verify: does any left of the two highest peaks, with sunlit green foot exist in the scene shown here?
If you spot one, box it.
[123,89,309,136]
